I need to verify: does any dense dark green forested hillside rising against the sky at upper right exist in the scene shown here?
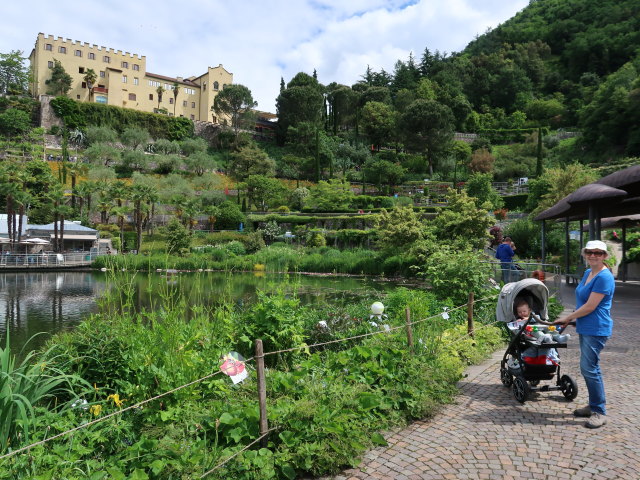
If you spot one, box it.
[294,0,640,163]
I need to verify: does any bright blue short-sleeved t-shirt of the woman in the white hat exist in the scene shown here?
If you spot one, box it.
[576,268,616,337]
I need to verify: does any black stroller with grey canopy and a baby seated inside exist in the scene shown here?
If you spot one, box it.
[496,278,578,403]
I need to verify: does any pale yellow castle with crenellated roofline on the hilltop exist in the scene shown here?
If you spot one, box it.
[29,33,233,123]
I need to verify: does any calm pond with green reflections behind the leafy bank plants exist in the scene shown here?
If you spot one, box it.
[0,271,408,353]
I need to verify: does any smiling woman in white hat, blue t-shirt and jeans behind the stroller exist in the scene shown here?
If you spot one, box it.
[554,240,616,428]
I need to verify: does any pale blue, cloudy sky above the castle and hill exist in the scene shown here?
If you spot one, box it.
[0,0,529,113]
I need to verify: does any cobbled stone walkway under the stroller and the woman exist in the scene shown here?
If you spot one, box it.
[332,282,640,480]
